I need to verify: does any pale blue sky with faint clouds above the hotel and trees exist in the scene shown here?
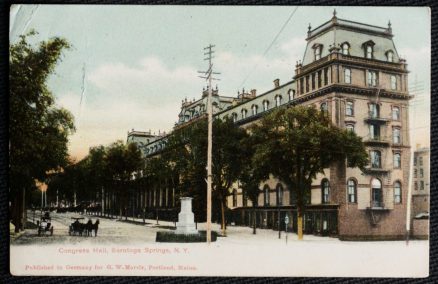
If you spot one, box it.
[10,5,431,160]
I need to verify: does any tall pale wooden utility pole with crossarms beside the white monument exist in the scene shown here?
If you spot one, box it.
[198,44,219,244]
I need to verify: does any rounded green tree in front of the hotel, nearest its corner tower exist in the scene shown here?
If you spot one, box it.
[252,106,368,239]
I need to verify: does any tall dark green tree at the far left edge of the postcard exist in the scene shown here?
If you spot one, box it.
[9,32,75,231]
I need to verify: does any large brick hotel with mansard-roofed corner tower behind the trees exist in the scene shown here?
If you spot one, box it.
[128,12,411,240]
